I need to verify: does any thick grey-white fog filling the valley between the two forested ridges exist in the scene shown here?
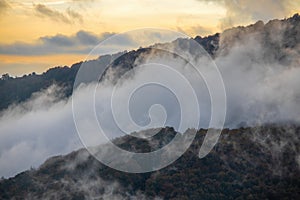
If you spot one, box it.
[0,19,300,177]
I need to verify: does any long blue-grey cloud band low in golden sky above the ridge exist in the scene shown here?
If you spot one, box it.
[0,29,182,56]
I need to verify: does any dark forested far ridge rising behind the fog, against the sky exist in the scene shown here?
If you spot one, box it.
[0,14,300,110]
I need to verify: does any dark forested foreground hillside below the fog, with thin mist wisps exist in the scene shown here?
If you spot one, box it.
[0,125,300,199]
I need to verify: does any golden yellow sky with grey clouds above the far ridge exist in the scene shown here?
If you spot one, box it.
[0,0,300,75]
